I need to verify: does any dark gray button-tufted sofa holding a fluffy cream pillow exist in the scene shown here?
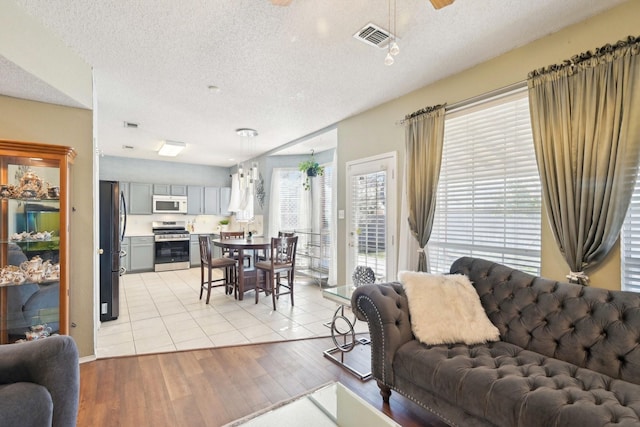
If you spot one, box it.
[352,257,640,427]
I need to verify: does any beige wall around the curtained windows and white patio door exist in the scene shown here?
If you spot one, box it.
[338,0,640,289]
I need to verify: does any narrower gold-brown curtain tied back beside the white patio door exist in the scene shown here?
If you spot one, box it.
[404,105,445,271]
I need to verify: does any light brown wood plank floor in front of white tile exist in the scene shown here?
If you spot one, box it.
[78,338,446,427]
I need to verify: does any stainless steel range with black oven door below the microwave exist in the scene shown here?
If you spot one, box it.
[151,221,190,271]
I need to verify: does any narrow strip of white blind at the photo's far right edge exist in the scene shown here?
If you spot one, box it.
[621,173,640,292]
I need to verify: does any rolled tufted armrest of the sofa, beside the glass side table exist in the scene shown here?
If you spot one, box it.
[351,283,414,387]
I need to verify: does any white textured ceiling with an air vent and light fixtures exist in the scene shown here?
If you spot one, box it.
[0,0,624,166]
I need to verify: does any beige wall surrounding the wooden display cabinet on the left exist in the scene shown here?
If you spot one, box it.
[0,96,96,356]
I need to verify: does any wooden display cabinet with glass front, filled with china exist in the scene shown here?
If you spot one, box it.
[0,140,76,344]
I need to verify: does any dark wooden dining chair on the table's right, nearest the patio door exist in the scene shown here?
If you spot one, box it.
[256,236,298,310]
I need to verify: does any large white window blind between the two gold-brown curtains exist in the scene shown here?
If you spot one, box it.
[427,91,541,274]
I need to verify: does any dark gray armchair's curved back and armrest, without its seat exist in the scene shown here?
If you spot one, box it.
[0,335,80,427]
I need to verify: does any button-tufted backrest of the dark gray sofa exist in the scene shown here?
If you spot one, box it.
[451,257,640,384]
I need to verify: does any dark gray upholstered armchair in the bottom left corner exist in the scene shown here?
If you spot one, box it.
[0,335,80,427]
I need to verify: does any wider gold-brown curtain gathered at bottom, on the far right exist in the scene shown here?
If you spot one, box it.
[527,37,640,284]
